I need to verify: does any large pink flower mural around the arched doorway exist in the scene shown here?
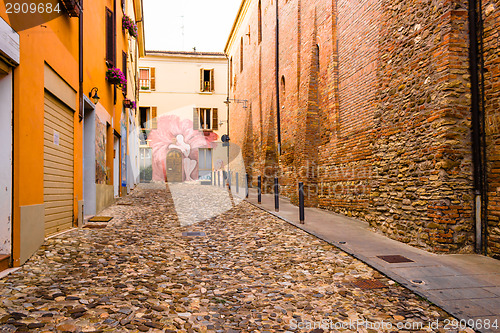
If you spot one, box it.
[150,115,218,181]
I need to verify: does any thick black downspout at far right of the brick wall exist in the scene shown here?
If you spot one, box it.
[469,0,484,253]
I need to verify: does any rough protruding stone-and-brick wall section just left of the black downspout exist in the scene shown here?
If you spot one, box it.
[370,1,473,251]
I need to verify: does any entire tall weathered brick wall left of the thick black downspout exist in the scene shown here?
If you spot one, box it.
[230,0,473,252]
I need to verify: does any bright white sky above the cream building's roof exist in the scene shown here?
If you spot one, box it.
[143,0,241,52]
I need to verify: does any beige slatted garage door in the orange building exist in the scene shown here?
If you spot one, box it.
[43,92,74,236]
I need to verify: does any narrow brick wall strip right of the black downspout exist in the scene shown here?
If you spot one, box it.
[482,0,500,257]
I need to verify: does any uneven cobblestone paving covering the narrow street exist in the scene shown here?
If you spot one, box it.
[0,184,472,332]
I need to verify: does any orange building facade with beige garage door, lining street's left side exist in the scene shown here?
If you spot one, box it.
[0,0,144,267]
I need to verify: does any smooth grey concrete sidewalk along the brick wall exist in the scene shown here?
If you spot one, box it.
[247,189,500,332]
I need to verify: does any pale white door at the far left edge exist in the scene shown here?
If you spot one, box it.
[0,63,12,254]
